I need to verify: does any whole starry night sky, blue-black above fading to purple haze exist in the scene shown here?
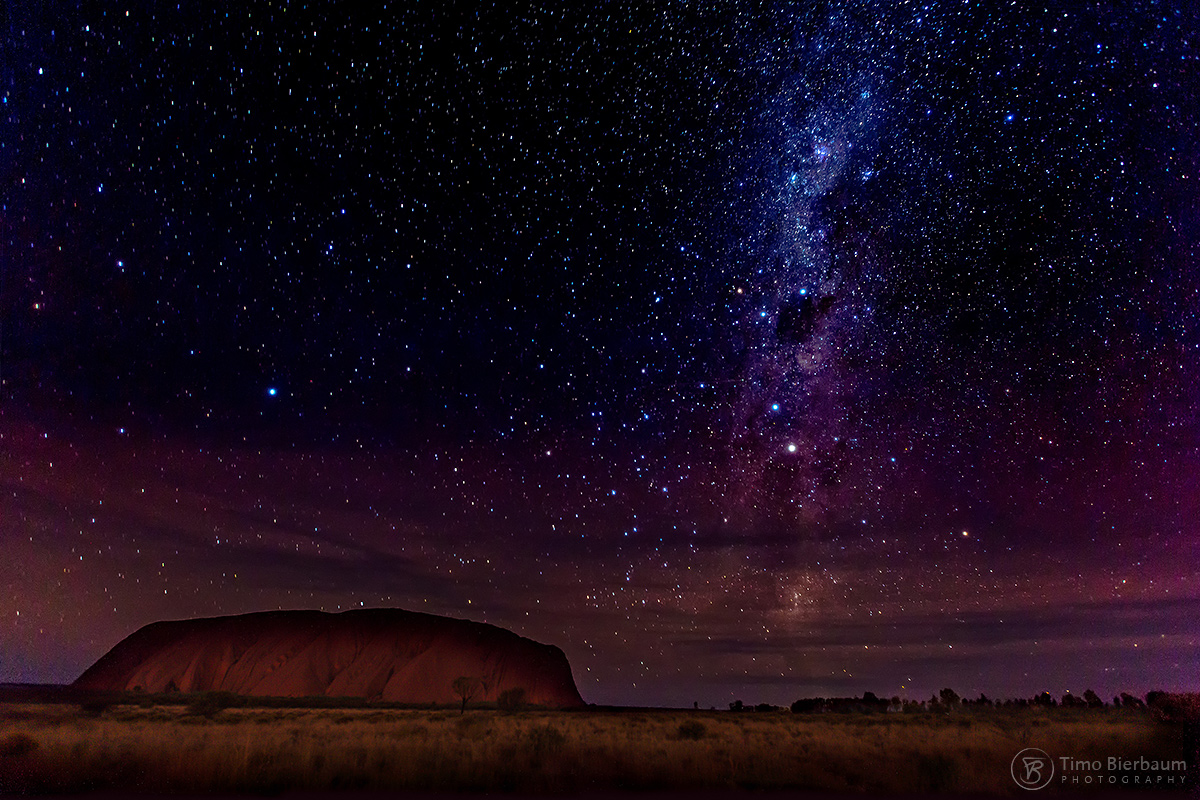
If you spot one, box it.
[0,0,1200,708]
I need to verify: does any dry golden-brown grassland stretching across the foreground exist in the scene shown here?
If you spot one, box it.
[0,703,1195,795]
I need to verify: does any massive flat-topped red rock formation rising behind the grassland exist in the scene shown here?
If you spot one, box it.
[74,608,583,708]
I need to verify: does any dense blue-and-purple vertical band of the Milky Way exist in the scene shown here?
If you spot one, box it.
[715,14,881,532]
